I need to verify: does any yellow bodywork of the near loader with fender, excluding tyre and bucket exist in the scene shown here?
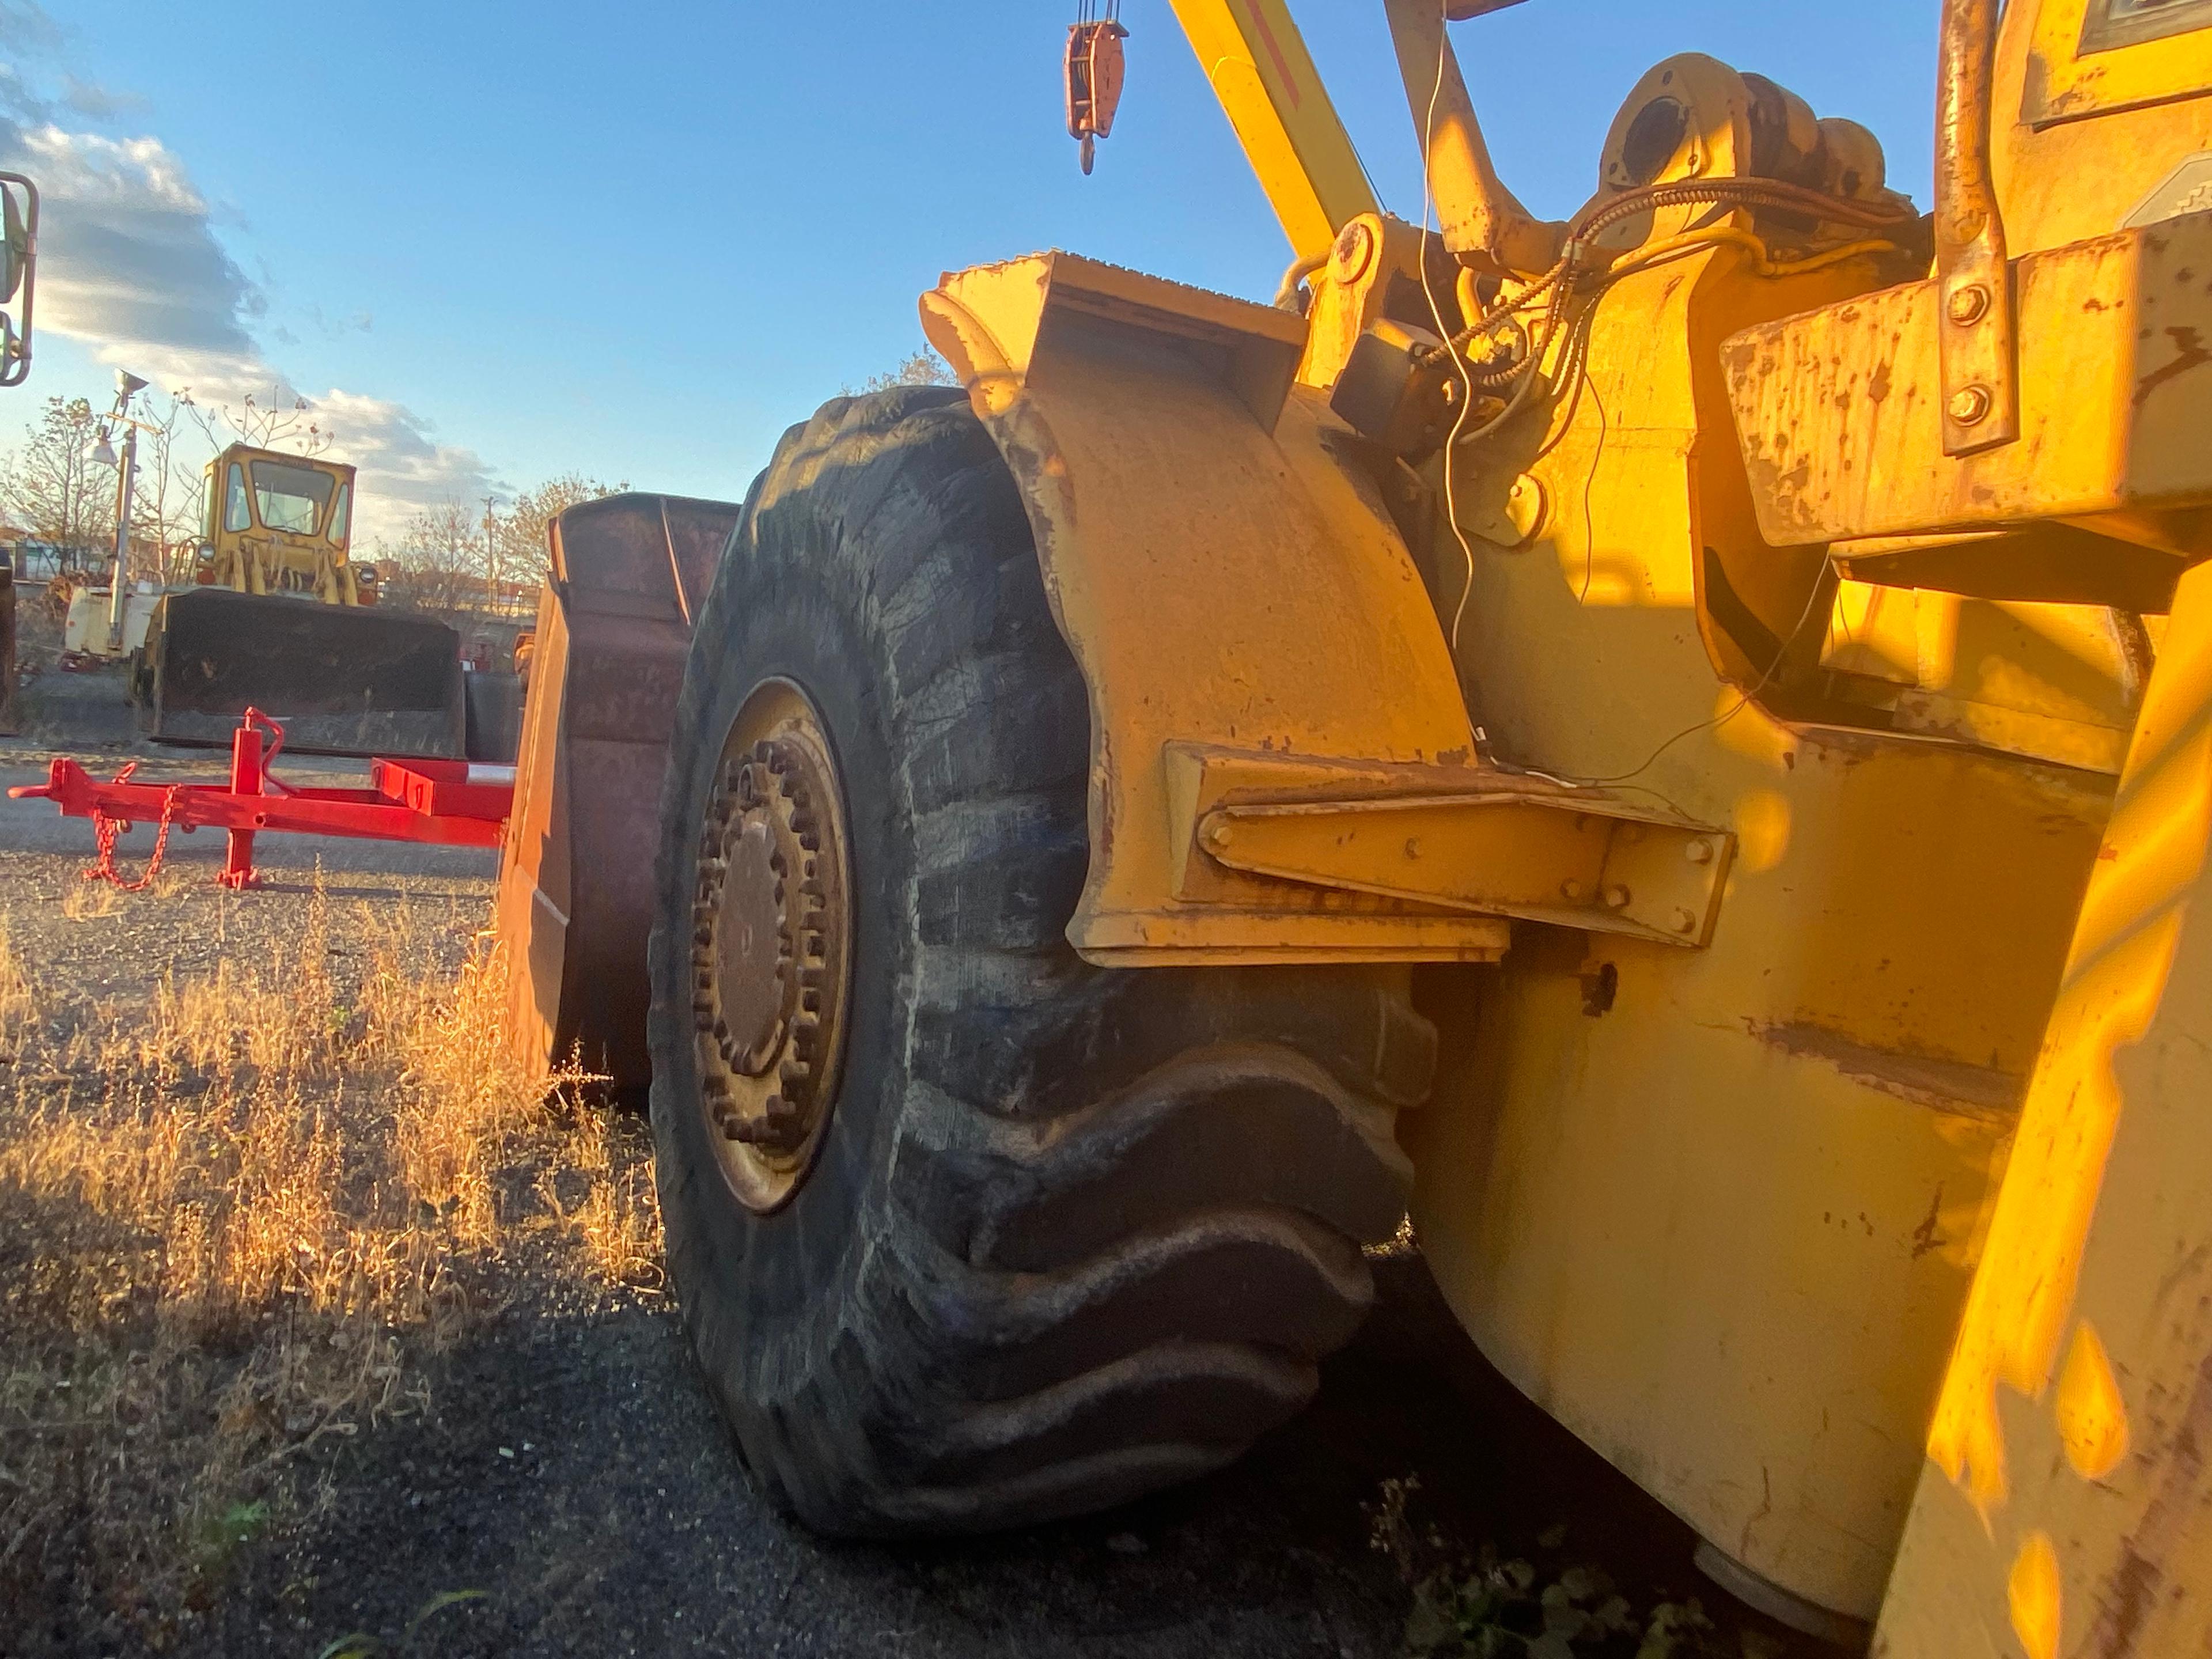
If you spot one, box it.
[898,0,2212,1659]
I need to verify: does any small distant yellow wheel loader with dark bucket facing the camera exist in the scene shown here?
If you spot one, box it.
[131,445,467,759]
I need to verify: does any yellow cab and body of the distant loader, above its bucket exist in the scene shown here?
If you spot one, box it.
[199,445,362,604]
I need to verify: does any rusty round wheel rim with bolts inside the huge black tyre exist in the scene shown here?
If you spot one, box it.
[692,679,851,1212]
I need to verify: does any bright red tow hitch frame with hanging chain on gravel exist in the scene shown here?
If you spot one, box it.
[9,708,516,892]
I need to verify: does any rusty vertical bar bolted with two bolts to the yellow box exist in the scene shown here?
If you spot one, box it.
[1936,0,2020,456]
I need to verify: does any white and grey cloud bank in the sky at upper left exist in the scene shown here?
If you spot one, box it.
[0,84,502,544]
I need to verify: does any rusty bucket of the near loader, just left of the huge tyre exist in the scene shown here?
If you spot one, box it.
[498,495,739,1093]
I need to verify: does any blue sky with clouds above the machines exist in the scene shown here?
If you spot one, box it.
[0,0,1938,535]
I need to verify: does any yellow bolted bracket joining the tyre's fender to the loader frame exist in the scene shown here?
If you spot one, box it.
[1168,743,1736,947]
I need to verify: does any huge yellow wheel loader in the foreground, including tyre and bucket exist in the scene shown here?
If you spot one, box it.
[500,0,2212,1659]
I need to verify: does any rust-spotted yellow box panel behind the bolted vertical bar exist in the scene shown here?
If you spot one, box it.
[1721,214,2212,551]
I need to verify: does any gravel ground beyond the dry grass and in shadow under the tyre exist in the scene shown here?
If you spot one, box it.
[0,721,1794,1659]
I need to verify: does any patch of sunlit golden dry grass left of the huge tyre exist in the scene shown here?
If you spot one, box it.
[0,889,659,1639]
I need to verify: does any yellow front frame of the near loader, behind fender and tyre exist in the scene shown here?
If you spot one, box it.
[1404,240,2110,1617]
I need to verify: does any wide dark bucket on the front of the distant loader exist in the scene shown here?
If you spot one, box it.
[132,588,467,761]
